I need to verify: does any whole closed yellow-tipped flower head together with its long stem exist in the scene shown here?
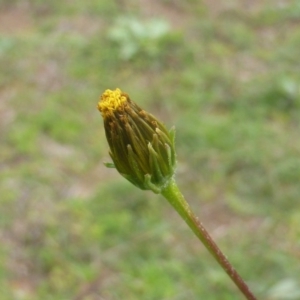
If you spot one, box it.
[98,89,256,300]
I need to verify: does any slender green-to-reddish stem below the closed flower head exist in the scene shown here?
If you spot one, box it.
[161,179,256,300]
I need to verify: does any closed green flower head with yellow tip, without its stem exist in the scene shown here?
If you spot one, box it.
[98,89,176,193]
